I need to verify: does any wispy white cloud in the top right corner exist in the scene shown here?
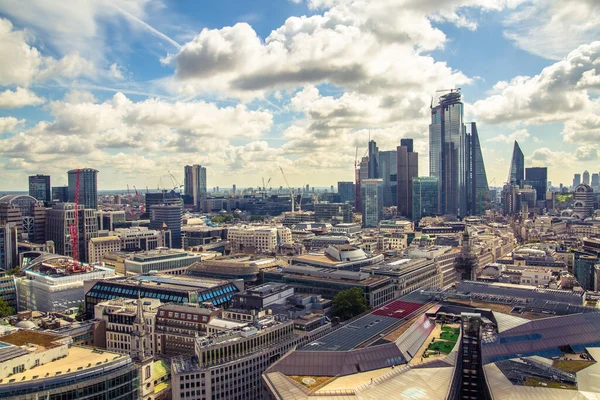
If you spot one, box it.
[504,0,600,60]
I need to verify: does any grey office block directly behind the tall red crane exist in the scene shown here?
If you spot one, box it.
[46,203,98,262]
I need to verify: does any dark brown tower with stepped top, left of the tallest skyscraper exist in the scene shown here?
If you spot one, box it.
[396,139,419,218]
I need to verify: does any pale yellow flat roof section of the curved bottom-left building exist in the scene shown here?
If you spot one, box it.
[0,346,125,385]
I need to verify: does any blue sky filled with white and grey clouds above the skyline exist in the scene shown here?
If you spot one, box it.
[0,0,600,190]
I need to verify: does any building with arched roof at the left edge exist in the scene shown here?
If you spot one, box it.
[0,194,46,243]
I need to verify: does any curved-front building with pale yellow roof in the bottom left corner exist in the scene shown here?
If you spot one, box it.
[0,330,139,400]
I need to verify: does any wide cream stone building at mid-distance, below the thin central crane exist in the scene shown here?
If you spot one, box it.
[227,226,292,253]
